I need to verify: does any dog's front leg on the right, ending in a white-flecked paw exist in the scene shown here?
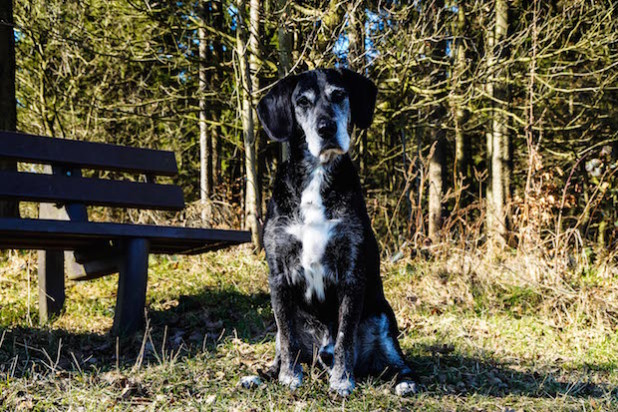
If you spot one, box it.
[330,290,363,396]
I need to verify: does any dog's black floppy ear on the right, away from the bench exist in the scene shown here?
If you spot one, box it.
[341,69,378,129]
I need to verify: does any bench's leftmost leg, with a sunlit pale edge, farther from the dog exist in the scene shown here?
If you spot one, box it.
[38,250,65,324]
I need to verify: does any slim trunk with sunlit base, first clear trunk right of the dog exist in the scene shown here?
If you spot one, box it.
[428,0,446,242]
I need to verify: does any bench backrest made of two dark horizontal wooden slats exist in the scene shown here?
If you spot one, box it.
[0,131,185,210]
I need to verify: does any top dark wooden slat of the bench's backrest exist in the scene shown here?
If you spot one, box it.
[0,131,178,176]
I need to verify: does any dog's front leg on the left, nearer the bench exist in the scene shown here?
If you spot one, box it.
[270,276,303,390]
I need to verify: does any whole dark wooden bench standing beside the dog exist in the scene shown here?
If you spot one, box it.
[0,132,251,335]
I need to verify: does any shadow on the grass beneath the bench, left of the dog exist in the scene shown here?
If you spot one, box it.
[0,288,274,379]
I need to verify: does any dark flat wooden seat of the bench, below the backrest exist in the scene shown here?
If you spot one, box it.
[0,218,251,254]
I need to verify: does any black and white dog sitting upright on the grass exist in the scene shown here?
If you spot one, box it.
[248,69,415,396]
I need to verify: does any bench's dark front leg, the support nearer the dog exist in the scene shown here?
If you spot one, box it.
[112,239,150,336]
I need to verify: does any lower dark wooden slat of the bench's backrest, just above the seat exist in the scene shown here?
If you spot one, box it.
[0,171,185,210]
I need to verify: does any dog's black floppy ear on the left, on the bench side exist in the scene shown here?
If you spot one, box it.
[257,75,298,142]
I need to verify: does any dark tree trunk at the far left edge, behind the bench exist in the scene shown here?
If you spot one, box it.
[0,0,19,217]
